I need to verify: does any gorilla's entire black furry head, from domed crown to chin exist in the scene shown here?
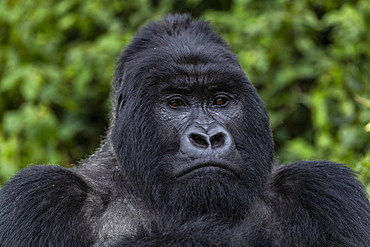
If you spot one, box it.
[110,15,273,224]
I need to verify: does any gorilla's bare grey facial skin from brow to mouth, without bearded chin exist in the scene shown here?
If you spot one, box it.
[157,76,242,178]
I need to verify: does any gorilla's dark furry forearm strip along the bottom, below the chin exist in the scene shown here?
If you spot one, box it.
[112,215,280,247]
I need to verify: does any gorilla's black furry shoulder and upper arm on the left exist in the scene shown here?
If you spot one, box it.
[0,166,100,247]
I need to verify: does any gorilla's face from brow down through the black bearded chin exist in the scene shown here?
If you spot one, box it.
[155,73,256,220]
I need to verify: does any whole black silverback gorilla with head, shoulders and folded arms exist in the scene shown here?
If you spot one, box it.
[0,14,370,247]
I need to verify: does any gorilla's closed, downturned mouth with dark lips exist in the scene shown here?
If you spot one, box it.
[175,162,240,178]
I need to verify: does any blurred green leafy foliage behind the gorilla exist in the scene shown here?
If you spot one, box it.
[0,0,370,192]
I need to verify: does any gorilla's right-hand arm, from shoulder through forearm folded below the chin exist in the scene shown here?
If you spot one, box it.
[116,161,370,247]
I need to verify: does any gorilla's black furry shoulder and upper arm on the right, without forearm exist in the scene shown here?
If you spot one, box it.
[269,161,370,247]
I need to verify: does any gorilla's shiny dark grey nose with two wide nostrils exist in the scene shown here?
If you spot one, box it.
[180,124,232,154]
